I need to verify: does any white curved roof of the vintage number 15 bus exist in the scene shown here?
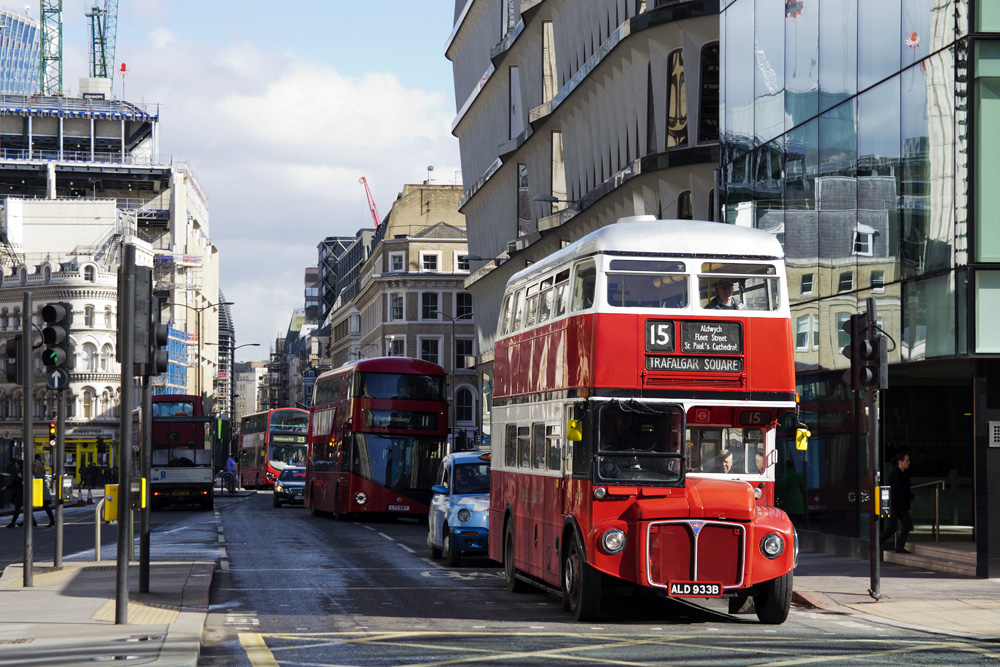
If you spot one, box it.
[507,218,785,285]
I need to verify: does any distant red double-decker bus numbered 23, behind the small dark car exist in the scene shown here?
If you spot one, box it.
[237,408,309,489]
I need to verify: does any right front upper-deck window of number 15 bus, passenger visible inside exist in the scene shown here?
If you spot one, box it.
[698,262,781,311]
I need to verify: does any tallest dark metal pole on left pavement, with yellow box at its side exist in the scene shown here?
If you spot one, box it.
[115,243,135,625]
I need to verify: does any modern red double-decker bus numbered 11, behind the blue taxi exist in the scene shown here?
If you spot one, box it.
[305,357,448,519]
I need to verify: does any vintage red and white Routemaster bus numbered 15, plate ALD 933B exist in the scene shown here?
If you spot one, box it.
[489,216,797,623]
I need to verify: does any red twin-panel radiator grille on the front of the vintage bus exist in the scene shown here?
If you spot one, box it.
[647,521,743,586]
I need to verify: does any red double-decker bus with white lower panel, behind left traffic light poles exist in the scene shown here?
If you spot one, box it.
[146,394,215,510]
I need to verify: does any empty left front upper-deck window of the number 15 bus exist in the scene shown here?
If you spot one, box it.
[607,259,688,308]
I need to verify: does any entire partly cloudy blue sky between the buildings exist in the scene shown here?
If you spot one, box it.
[8,0,460,359]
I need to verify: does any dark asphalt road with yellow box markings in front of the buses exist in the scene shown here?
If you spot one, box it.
[199,492,995,667]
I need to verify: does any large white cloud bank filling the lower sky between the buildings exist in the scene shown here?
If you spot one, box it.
[115,27,459,359]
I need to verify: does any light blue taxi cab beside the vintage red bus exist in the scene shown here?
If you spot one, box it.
[427,451,490,567]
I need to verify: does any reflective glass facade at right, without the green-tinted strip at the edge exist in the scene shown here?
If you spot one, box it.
[720,0,972,537]
